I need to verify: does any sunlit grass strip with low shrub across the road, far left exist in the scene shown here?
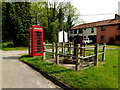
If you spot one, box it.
[2,42,28,50]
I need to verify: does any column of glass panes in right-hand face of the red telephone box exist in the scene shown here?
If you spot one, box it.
[35,32,42,53]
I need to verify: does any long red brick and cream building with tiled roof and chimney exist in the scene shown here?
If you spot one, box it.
[69,15,120,45]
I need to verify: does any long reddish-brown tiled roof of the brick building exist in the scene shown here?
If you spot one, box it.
[71,19,120,29]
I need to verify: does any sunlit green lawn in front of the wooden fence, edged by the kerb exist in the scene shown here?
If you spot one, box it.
[20,50,118,89]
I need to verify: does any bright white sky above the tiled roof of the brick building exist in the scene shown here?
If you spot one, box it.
[70,0,120,24]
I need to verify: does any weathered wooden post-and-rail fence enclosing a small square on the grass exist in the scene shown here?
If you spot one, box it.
[43,42,106,71]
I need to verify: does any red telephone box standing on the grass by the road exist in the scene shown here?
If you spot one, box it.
[28,25,43,56]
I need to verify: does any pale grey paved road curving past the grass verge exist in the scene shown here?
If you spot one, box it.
[2,51,59,88]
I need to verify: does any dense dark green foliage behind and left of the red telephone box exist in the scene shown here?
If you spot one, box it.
[2,2,32,46]
